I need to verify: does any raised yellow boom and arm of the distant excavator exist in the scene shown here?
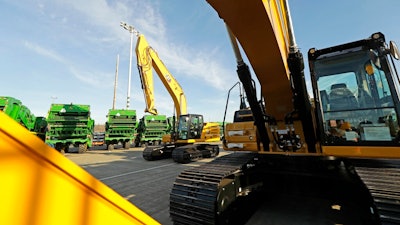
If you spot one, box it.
[135,34,187,118]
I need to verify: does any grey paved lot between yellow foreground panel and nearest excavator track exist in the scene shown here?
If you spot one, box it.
[65,148,227,225]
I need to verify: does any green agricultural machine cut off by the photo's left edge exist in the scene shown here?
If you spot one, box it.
[0,96,47,141]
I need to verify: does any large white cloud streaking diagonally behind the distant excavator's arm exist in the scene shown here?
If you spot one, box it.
[35,0,232,90]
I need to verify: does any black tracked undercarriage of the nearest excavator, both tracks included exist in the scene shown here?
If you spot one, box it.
[170,153,400,224]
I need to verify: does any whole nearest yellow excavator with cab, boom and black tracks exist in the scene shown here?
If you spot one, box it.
[170,0,400,224]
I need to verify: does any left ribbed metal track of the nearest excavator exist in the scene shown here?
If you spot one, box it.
[170,153,254,225]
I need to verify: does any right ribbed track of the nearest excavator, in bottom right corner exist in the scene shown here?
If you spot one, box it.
[354,161,400,225]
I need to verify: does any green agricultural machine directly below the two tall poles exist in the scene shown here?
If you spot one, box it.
[104,109,137,150]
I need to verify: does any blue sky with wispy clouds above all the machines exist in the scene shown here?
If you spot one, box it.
[0,0,400,124]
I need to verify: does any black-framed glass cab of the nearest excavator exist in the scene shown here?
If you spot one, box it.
[309,33,400,146]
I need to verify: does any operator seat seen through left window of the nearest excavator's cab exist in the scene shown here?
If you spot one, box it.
[329,83,358,110]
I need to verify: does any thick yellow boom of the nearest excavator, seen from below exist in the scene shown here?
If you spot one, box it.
[207,0,293,120]
